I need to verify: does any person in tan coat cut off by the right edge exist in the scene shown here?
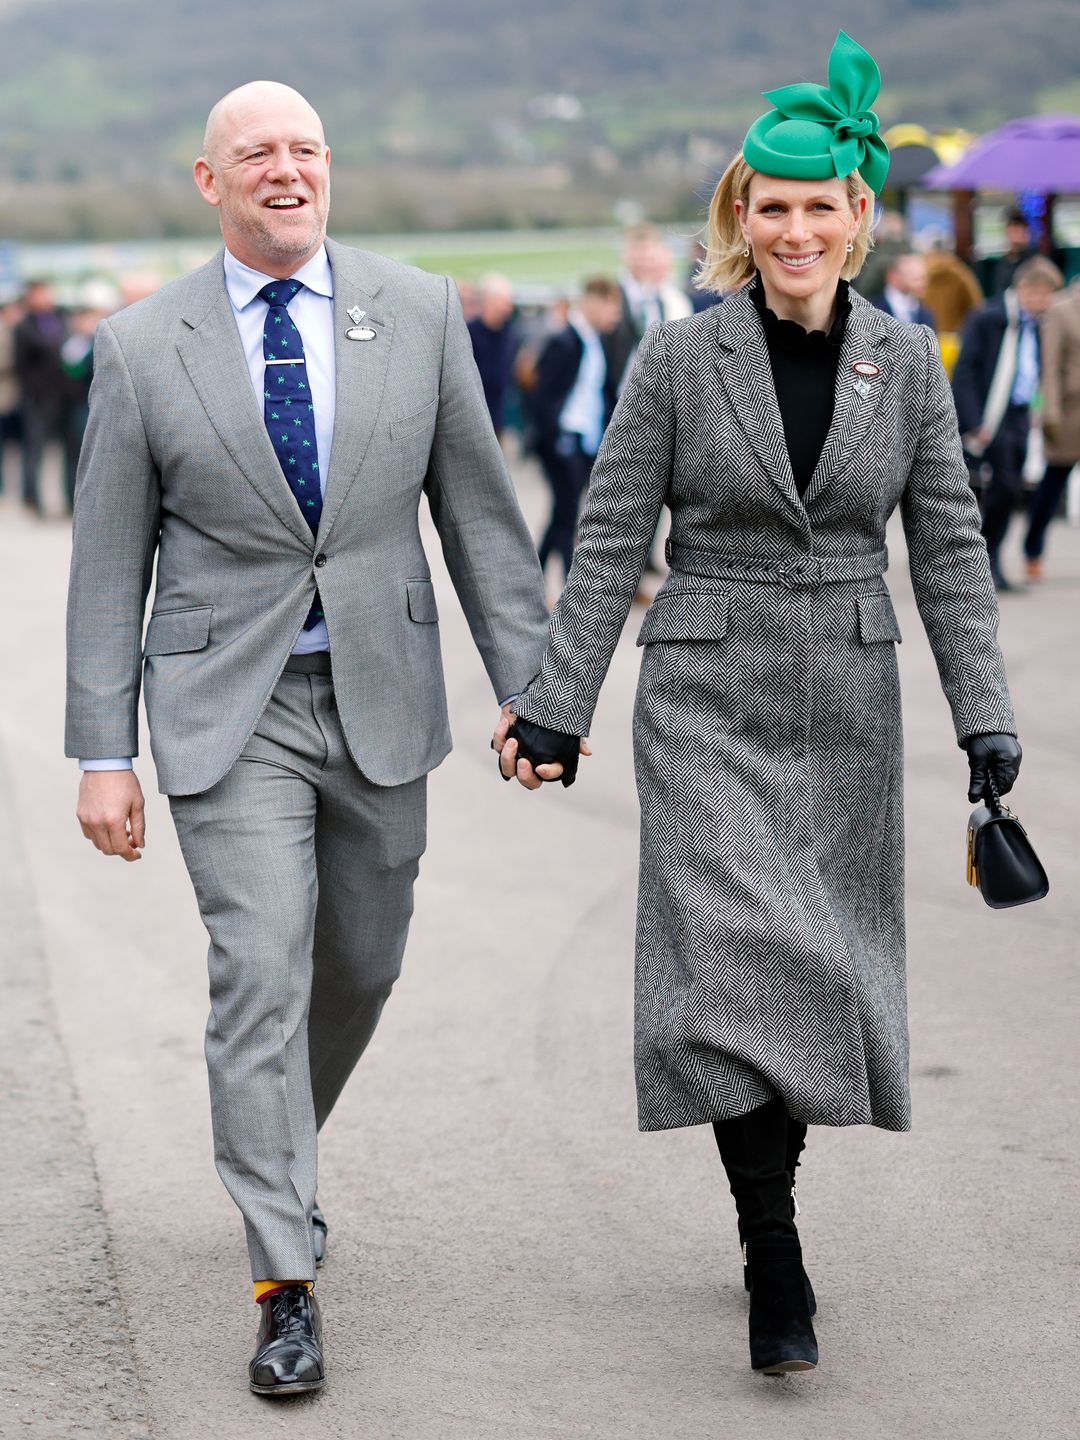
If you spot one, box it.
[1024,279,1080,580]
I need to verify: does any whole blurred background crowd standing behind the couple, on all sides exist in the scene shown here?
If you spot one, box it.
[0,210,1080,590]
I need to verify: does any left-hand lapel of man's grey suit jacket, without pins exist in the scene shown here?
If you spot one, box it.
[177,253,312,549]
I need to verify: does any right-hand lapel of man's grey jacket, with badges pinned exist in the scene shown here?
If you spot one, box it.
[318,240,393,546]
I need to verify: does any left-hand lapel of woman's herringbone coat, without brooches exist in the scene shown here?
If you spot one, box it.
[716,287,806,523]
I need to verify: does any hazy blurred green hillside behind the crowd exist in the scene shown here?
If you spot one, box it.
[0,0,1080,238]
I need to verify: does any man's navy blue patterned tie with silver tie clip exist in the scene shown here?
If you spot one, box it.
[259,279,323,629]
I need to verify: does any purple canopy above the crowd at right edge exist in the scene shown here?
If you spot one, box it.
[923,115,1080,194]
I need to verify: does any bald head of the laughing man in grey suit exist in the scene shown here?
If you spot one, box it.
[194,81,330,278]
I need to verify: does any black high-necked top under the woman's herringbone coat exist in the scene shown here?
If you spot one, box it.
[750,275,851,495]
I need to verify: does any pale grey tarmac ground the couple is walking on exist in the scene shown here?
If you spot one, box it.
[0,452,1080,1440]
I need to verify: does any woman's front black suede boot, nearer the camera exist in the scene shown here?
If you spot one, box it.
[713,1099,818,1375]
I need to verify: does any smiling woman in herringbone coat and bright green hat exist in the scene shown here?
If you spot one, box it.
[492,32,1021,1374]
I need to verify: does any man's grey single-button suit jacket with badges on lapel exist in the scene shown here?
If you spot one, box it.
[66,240,547,795]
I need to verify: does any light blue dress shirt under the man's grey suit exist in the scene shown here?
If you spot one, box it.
[79,246,337,770]
